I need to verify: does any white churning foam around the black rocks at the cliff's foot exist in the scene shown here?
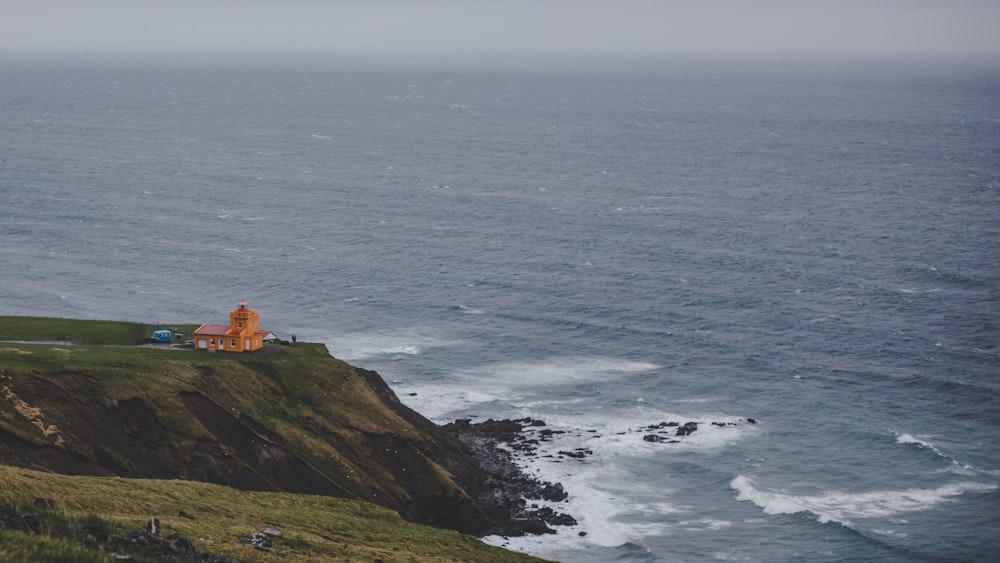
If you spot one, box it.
[480,405,754,553]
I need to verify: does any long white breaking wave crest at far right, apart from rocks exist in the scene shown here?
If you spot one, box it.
[729,475,997,526]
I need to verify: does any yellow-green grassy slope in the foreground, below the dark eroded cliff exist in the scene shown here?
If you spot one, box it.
[0,465,538,561]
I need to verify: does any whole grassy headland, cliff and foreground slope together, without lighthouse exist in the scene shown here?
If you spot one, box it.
[0,317,548,561]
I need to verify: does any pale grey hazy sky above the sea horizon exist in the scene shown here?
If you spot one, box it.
[0,0,1000,57]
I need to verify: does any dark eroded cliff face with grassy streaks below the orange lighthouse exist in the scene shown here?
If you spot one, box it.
[0,348,510,535]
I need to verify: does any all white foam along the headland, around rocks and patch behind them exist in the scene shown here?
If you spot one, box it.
[393,356,756,554]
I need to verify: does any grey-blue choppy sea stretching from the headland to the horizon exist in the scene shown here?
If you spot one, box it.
[0,54,1000,562]
